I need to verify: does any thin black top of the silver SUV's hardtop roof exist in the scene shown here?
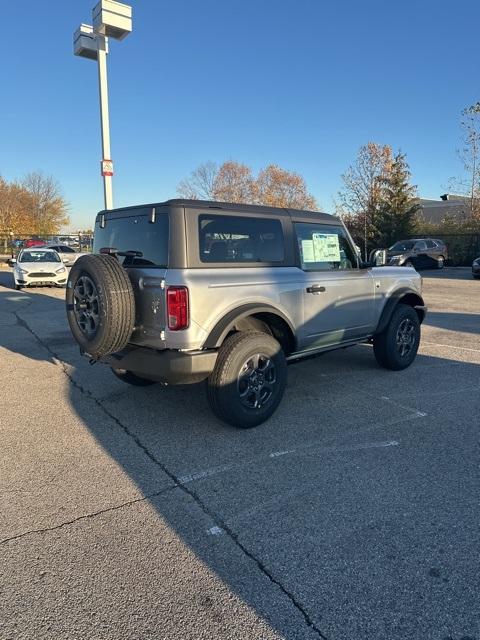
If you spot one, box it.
[97,198,338,224]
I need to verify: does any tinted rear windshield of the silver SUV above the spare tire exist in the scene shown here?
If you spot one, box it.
[93,210,169,267]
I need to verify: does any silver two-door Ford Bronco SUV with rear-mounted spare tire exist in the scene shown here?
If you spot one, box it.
[66,200,426,428]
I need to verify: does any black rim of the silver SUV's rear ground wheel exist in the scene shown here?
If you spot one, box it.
[237,353,277,410]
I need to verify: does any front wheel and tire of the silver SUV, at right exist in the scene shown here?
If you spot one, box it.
[373,304,420,371]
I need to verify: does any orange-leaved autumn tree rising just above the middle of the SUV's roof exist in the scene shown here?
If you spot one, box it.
[256,164,318,210]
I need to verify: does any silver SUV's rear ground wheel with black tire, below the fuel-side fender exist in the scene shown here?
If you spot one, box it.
[207,331,287,429]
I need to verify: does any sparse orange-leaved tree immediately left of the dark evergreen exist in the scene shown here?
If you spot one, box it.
[338,142,392,260]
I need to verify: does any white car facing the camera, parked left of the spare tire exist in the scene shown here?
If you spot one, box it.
[12,247,68,291]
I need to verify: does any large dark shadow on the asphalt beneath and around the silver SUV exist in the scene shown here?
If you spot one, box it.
[0,282,479,640]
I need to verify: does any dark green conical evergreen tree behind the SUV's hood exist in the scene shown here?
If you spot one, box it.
[375,151,418,247]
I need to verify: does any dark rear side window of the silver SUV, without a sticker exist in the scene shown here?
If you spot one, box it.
[199,215,285,263]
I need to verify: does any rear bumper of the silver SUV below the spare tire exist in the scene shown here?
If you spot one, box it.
[101,345,218,384]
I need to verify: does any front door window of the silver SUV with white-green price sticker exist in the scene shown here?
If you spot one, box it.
[295,222,357,271]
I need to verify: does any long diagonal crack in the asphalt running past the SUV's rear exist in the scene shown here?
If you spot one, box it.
[13,304,327,640]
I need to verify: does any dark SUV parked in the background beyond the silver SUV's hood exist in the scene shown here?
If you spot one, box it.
[387,238,448,269]
